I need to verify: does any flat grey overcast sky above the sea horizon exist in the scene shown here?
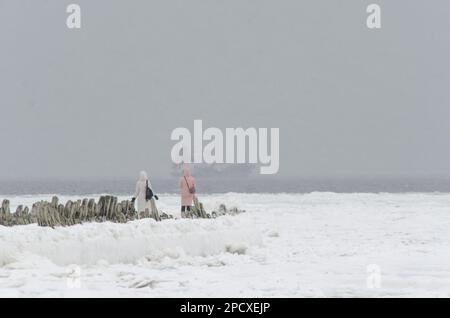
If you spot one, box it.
[0,0,450,178]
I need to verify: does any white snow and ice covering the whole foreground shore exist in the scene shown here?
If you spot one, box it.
[0,193,450,297]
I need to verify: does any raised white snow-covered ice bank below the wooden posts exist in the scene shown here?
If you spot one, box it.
[0,216,261,266]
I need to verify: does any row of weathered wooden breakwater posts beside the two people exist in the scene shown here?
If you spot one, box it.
[0,195,243,227]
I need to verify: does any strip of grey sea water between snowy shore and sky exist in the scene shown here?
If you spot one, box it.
[0,177,450,196]
